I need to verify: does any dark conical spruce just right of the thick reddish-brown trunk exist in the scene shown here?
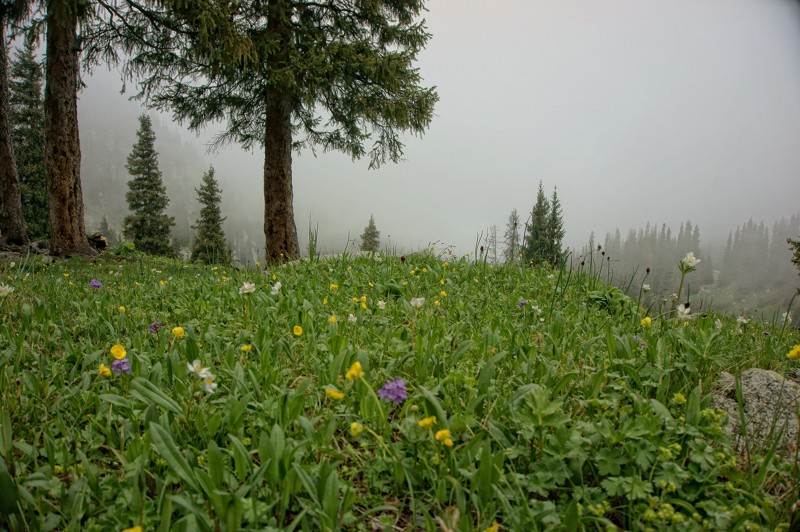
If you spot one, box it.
[123,115,175,256]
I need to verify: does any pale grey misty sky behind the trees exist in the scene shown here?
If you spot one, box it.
[80,0,800,253]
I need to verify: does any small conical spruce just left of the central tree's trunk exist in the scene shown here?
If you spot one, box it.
[192,166,231,264]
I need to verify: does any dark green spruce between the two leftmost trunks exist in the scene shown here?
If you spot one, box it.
[9,34,50,239]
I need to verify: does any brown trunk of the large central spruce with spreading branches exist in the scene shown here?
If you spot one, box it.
[264,0,300,264]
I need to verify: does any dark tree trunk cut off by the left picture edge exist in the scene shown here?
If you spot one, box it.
[0,20,25,245]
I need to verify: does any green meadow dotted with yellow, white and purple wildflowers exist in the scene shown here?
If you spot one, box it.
[0,250,800,531]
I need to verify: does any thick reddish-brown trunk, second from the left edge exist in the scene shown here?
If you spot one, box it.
[44,6,94,257]
